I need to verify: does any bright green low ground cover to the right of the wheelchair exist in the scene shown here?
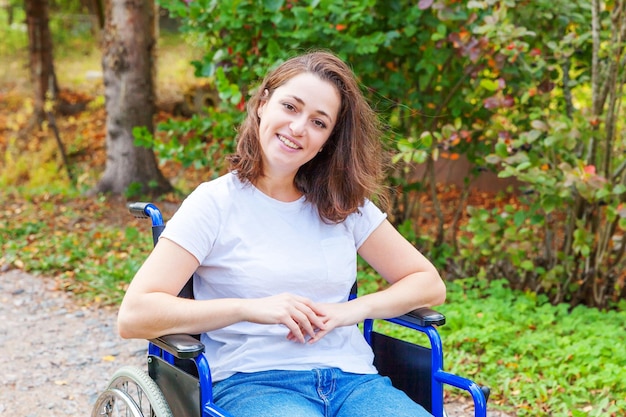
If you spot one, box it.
[361,272,626,417]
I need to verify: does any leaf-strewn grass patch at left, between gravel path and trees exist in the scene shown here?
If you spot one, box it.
[0,192,150,304]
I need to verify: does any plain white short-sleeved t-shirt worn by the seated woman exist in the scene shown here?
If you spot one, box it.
[162,173,386,381]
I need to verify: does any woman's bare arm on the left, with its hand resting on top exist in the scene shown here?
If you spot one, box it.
[118,238,324,342]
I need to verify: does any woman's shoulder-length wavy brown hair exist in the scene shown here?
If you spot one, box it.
[229,51,386,223]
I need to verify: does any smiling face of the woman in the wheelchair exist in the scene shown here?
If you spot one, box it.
[258,73,341,176]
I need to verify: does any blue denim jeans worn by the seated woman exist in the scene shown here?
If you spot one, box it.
[213,368,431,417]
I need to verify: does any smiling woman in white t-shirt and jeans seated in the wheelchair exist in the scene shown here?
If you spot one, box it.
[118,52,445,417]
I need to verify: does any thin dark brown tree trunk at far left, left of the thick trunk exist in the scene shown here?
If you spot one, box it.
[25,0,59,125]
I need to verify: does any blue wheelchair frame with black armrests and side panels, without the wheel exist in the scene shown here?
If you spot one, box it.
[128,203,489,417]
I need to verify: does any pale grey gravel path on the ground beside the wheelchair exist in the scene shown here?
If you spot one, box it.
[0,270,508,417]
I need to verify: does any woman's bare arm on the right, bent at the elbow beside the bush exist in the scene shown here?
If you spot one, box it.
[311,220,446,342]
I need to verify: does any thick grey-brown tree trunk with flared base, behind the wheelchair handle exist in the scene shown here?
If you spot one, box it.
[93,0,172,195]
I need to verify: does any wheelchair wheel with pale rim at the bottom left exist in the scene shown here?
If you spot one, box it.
[91,366,173,417]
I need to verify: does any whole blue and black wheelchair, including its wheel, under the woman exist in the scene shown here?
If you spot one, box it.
[91,203,489,417]
